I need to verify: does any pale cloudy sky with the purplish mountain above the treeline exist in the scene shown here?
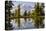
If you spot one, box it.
[12,1,35,14]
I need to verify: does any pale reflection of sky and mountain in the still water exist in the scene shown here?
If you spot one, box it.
[11,18,34,29]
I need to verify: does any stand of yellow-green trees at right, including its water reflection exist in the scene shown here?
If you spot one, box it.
[32,3,44,28]
